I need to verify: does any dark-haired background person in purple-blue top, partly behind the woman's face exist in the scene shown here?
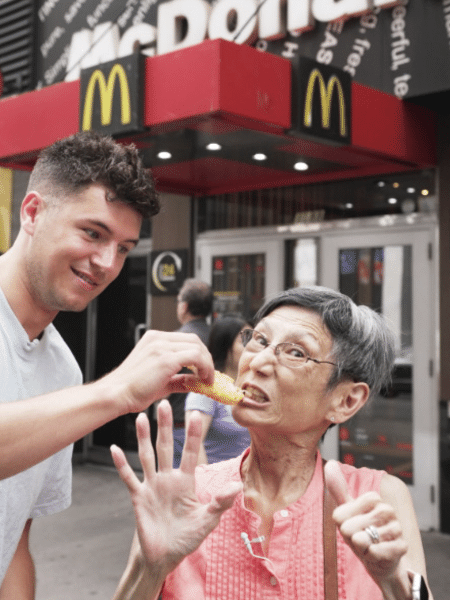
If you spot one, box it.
[185,315,250,464]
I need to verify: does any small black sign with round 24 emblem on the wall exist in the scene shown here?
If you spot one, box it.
[150,249,188,296]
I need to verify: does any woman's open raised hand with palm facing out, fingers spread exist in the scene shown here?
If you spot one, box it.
[111,400,242,586]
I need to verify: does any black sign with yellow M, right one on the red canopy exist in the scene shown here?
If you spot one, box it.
[292,57,352,144]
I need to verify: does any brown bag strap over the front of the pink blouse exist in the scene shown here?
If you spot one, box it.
[322,459,339,600]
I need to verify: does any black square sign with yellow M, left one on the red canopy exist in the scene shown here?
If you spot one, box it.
[80,54,144,135]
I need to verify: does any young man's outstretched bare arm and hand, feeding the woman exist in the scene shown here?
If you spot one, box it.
[0,331,214,479]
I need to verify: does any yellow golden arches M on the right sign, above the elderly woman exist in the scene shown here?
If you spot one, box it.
[303,68,347,137]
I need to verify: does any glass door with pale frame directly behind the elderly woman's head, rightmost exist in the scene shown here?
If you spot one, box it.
[321,229,438,529]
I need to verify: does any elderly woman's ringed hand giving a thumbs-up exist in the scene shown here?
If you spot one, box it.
[325,461,411,599]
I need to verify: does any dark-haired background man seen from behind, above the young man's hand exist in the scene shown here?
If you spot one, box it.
[168,278,213,466]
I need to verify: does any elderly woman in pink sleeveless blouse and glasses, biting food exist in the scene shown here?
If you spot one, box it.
[112,287,431,600]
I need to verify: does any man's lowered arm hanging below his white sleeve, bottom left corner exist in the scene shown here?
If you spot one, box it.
[0,519,36,600]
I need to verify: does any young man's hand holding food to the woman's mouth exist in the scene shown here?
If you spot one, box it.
[103,331,214,414]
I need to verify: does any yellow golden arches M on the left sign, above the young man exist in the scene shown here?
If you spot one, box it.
[81,64,131,131]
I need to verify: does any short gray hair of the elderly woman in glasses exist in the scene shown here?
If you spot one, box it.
[255,286,395,397]
